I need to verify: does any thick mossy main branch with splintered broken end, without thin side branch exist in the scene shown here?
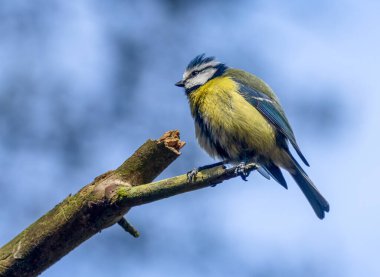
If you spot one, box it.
[0,131,184,276]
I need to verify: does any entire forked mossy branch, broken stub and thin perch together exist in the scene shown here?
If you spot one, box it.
[0,131,256,276]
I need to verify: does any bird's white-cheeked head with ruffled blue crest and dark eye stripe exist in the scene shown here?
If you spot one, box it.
[175,54,227,94]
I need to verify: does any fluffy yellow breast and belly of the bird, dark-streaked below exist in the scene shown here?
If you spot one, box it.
[189,77,276,161]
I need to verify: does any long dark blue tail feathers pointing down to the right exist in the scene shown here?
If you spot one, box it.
[290,151,330,219]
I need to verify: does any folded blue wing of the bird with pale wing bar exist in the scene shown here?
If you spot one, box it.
[239,82,309,166]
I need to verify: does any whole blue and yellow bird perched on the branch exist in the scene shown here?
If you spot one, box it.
[175,54,329,219]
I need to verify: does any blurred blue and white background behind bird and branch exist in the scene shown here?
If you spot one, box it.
[0,0,380,276]
